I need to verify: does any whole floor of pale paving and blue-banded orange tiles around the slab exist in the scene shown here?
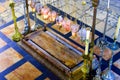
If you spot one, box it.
[0,0,120,80]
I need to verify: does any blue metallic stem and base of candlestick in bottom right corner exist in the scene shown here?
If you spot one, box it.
[102,51,115,80]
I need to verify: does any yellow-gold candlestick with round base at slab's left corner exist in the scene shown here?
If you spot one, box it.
[9,3,22,42]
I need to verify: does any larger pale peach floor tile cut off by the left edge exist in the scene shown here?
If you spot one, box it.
[0,48,23,72]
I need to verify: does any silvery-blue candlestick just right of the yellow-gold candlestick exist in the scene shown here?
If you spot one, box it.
[22,0,29,35]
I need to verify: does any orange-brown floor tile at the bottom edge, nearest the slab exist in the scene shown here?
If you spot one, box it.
[5,62,42,80]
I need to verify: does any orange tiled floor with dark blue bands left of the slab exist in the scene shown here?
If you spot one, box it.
[0,17,59,80]
